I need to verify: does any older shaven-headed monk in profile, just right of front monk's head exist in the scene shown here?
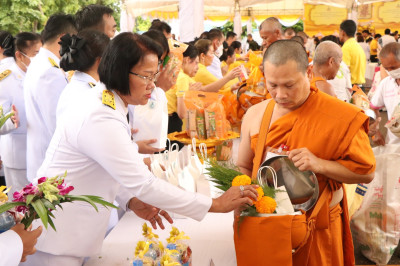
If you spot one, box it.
[310,41,342,97]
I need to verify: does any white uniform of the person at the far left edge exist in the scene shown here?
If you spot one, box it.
[0,63,26,169]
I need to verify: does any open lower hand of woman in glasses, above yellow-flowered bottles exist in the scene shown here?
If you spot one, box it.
[128,198,173,229]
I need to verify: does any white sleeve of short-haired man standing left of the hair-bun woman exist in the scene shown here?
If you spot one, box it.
[35,67,68,136]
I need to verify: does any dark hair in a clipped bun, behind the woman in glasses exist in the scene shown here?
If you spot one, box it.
[60,30,110,71]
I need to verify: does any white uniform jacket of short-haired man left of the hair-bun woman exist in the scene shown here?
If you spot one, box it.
[24,47,67,180]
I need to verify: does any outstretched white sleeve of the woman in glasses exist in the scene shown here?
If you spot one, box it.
[77,113,212,220]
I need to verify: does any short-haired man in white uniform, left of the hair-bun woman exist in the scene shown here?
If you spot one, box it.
[24,14,76,180]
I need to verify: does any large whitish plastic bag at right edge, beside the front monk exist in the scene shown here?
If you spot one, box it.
[351,145,400,264]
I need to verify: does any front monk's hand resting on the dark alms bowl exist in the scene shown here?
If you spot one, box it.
[289,148,323,173]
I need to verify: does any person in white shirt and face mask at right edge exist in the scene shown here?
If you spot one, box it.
[370,42,400,145]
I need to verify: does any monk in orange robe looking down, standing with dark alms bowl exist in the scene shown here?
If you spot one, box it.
[237,40,375,266]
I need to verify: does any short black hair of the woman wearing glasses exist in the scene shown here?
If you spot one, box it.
[98,32,162,95]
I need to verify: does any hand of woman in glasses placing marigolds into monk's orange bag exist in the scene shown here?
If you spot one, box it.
[209,185,258,213]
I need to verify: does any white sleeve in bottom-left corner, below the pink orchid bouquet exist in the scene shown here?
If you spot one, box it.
[0,230,23,266]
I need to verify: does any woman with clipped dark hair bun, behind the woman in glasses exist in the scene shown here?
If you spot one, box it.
[56,30,110,120]
